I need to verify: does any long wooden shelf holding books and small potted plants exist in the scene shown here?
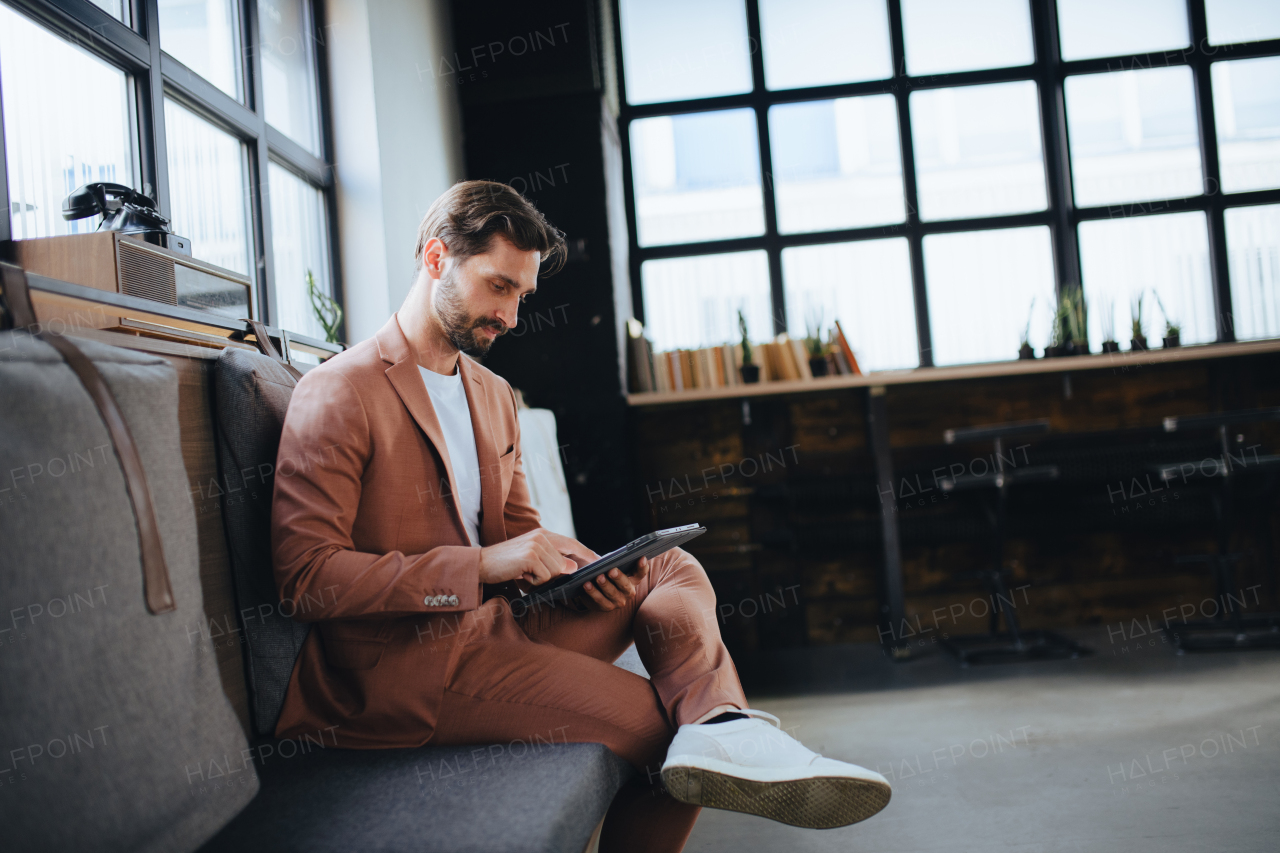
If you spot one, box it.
[627,339,1280,406]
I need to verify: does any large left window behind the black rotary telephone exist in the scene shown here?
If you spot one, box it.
[0,0,339,338]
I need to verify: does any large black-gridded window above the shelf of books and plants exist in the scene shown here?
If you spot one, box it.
[614,0,1280,369]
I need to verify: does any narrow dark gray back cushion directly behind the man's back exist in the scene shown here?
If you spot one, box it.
[214,347,308,735]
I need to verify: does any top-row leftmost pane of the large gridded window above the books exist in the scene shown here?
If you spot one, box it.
[621,0,751,104]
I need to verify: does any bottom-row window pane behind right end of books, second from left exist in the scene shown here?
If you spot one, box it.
[782,237,920,373]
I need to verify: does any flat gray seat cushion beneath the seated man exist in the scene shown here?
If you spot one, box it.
[201,742,634,853]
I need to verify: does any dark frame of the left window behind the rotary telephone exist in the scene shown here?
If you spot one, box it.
[0,0,343,332]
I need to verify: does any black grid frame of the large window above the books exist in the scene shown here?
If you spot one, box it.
[609,0,1280,368]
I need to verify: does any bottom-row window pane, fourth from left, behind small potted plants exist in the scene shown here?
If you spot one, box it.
[1080,211,1217,348]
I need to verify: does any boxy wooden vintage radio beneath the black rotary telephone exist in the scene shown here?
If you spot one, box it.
[13,231,252,328]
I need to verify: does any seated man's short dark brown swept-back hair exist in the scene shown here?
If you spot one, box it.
[413,181,566,275]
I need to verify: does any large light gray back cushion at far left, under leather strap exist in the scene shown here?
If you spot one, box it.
[0,332,259,853]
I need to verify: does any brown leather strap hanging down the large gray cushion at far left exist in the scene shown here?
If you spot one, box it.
[0,264,177,613]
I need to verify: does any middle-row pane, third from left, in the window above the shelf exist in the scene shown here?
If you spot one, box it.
[910,81,1048,219]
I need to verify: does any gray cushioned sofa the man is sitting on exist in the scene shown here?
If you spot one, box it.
[0,277,643,853]
